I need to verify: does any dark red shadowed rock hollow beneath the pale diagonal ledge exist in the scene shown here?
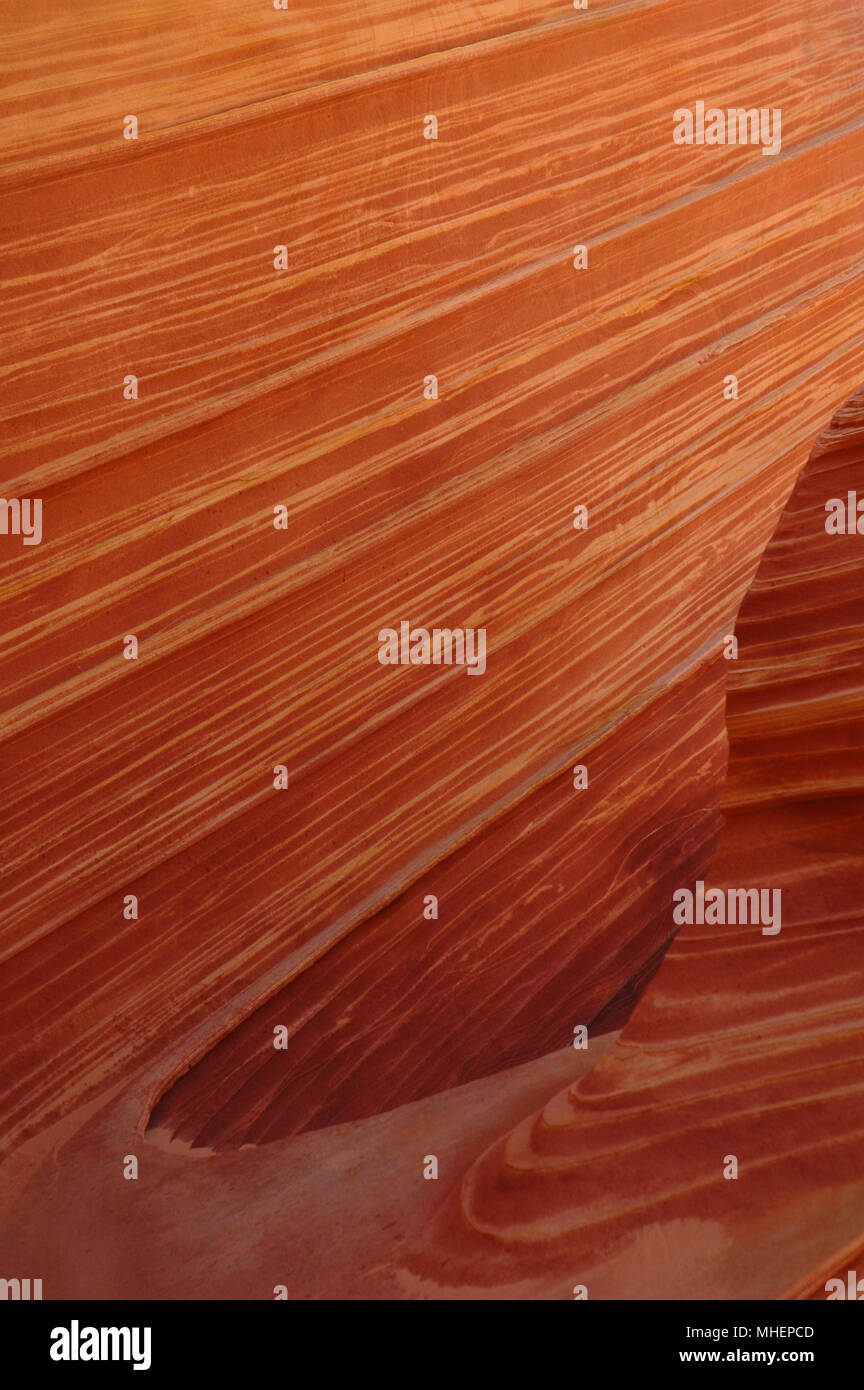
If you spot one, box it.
[151,663,725,1148]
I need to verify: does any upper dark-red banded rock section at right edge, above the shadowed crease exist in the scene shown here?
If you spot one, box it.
[724,392,864,808]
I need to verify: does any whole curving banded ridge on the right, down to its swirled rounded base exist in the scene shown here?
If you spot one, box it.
[450,391,864,1297]
